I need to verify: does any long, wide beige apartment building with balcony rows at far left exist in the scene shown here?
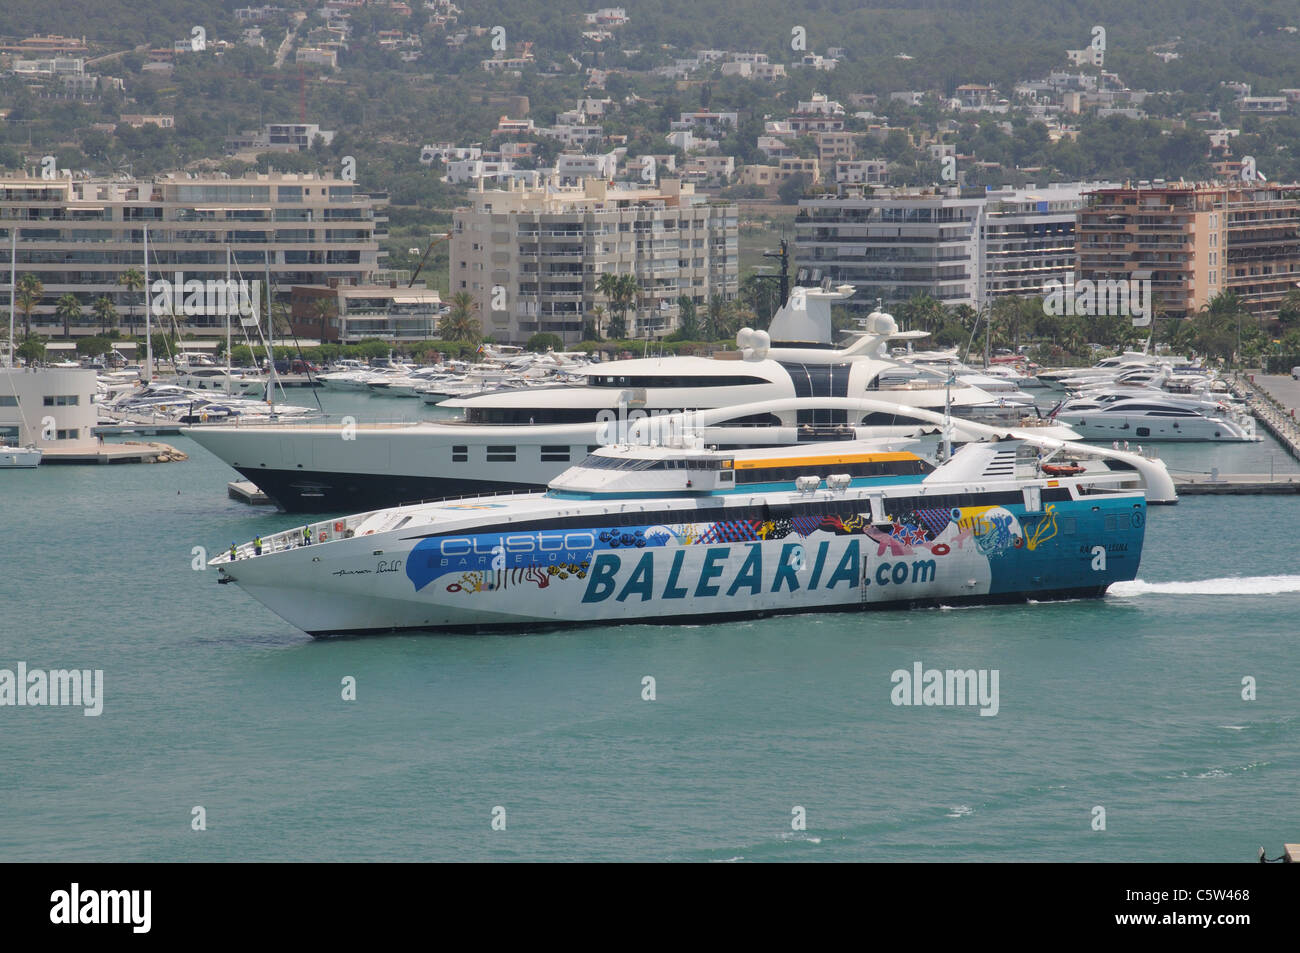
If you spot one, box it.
[0,173,387,335]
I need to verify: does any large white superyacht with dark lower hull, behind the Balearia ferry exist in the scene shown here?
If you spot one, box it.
[185,285,1050,512]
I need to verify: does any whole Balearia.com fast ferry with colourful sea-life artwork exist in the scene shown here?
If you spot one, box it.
[209,400,1177,636]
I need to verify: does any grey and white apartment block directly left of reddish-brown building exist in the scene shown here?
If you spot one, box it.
[796,183,1084,307]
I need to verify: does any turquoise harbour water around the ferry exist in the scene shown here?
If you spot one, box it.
[0,391,1300,862]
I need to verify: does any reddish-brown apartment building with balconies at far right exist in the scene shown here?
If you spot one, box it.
[1078,183,1300,317]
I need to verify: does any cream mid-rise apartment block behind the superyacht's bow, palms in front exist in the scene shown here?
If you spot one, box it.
[451,178,738,343]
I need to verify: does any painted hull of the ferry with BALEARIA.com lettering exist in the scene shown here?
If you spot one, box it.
[221,495,1145,636]
